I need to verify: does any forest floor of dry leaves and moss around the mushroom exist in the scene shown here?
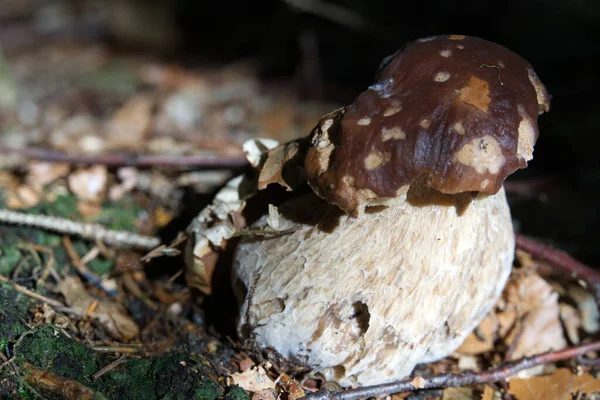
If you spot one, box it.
[0,28,600,400]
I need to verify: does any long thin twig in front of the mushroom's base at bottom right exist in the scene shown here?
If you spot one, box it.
[302,341,600,400]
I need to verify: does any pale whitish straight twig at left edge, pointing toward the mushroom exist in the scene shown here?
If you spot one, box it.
[0,209,160,249]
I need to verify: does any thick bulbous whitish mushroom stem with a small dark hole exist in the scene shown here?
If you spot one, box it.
[234,182,515,385]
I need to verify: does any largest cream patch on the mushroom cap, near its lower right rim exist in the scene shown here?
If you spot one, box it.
[453,135,506,174]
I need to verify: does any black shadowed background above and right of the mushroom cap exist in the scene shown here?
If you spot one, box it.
[0,0,600,266]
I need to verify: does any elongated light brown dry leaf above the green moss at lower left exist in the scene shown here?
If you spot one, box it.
[56,276,139,340]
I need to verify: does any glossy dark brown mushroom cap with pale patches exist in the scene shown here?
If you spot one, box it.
[305,35,550,214]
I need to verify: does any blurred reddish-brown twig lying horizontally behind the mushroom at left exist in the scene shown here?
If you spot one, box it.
[0,146,248,168]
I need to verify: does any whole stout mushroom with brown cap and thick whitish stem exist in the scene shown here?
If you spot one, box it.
[188,35,549,386]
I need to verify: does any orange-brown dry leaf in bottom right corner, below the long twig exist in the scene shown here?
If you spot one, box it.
[508,368,600,400]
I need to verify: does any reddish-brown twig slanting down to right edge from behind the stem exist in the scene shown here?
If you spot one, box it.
[516,234,600,304]
